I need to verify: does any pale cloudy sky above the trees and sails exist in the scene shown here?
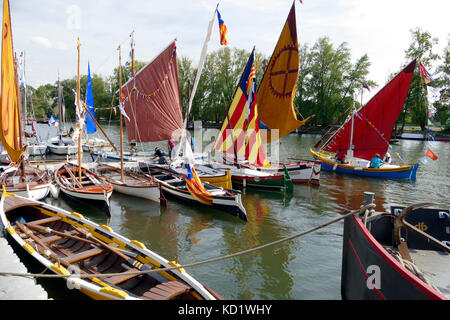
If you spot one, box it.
[10,0,450,100]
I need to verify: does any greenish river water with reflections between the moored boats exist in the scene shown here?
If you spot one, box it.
[25,124,450,300]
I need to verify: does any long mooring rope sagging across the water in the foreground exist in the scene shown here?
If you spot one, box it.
[0,204,375,278]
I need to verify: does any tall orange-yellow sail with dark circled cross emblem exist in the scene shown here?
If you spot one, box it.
[257,2,310,142]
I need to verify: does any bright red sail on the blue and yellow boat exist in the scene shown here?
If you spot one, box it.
[323,60,416,160]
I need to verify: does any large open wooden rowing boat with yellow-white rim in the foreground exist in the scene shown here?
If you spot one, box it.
[0,192,223,300]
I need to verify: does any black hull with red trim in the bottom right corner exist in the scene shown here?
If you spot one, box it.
[341,210,450,300]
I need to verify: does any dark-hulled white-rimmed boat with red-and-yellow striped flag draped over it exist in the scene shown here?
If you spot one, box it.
[139,163,247,221]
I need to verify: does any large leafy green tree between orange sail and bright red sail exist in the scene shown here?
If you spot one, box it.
[294,37,375,126]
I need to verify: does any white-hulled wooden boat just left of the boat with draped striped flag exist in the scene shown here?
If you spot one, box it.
[95,164,160,203]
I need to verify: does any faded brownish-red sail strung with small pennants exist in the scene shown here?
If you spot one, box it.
[122,42,183,142]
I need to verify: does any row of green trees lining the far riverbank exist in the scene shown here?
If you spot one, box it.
[28,28,450,132]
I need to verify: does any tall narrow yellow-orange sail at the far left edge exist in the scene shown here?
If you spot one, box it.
[0,0,25,162]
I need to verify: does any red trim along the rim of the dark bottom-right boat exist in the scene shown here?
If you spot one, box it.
[352,216,447,300]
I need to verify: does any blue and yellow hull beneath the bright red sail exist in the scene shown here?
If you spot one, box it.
[311,150,419,181]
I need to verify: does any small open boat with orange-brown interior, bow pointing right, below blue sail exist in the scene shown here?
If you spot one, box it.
[55,163,113,214]
